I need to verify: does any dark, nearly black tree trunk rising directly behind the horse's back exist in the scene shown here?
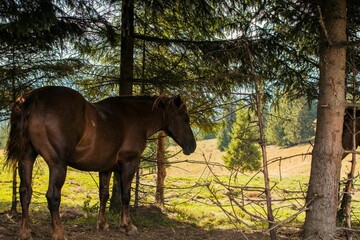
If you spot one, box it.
[110,0,134,212]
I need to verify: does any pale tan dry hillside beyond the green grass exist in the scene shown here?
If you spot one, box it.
[168,139,360,176]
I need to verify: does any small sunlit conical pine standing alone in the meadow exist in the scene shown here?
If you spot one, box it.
[224,106,261,171]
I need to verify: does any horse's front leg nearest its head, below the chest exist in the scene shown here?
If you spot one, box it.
[119,157,140,235]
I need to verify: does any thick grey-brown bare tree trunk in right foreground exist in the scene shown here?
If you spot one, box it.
[304,0,346,239]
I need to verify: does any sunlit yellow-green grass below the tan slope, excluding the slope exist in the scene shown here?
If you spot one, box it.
[0,142,360,232]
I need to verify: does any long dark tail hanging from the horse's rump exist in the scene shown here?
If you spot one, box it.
[4,92,35,171]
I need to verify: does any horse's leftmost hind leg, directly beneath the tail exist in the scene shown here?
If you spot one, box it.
[18,146,37,240]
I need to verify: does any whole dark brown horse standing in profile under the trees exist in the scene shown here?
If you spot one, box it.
[6,87,196,240]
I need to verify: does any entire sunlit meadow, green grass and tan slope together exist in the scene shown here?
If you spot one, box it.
[0,140,360,230]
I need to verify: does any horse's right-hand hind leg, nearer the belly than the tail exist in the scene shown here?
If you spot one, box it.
[46,164,67,240]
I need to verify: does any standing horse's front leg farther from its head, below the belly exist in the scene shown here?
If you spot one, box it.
[97,172,111,231]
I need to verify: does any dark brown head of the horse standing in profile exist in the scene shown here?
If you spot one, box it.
[164,96,196,155]
